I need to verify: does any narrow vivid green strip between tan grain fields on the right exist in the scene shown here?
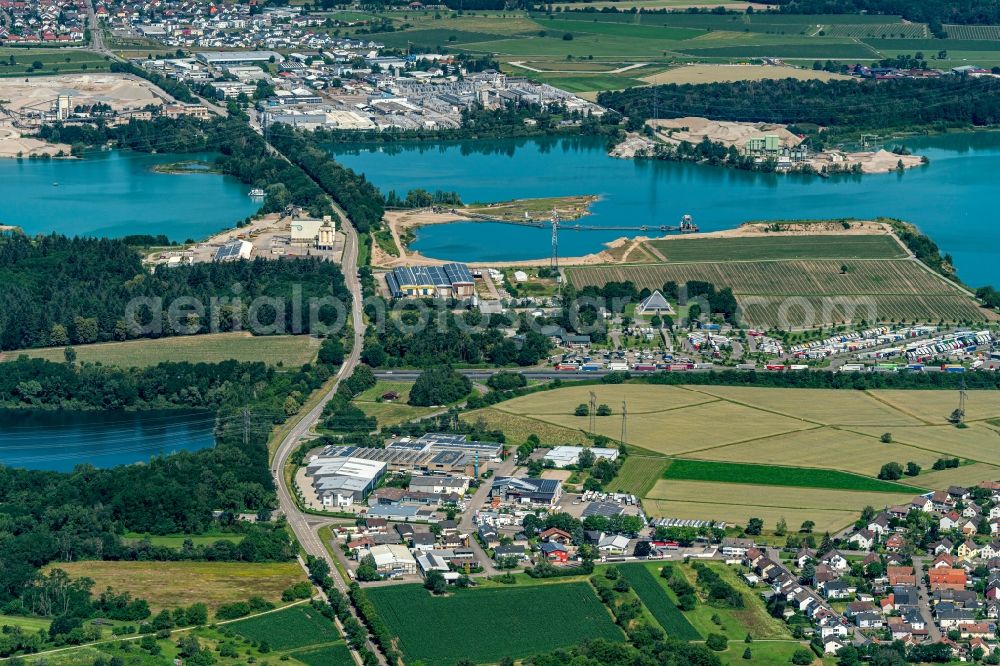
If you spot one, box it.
[663,459,913,493]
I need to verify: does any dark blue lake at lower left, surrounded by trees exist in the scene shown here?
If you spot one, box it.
[0,409,215,472]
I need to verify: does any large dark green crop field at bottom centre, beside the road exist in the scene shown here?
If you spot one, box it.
[368,582,624,666]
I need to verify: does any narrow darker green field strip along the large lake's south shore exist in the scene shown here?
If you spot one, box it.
[648,235,906,262]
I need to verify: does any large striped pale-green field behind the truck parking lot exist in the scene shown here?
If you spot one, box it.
[566,259,995,329]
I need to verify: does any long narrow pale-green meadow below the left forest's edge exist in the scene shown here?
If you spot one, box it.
[0,333,319,368]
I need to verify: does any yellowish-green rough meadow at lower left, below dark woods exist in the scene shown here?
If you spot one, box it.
[51,561,306,611]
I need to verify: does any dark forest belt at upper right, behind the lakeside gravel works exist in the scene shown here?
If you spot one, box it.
[598,76,1000,148]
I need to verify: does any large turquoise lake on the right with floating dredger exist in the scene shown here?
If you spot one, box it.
[332,132,1000,286]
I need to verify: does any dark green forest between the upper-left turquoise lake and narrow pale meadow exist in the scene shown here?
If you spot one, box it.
[0,234,350,350]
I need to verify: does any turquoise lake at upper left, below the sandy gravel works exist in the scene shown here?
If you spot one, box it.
[0,151,260,241]
